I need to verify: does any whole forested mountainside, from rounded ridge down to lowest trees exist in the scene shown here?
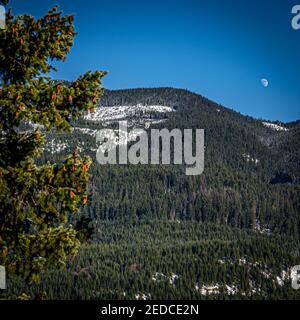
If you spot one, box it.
[8,88,300,299]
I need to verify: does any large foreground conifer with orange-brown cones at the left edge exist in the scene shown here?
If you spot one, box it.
[0,0,105,282]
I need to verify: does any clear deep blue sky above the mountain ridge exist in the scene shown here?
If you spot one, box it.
[6,0,300,121]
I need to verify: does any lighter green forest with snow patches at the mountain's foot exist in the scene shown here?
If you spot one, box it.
[4,220,300,300]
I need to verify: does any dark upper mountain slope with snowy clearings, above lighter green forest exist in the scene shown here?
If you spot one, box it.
[40,88,300,235]
